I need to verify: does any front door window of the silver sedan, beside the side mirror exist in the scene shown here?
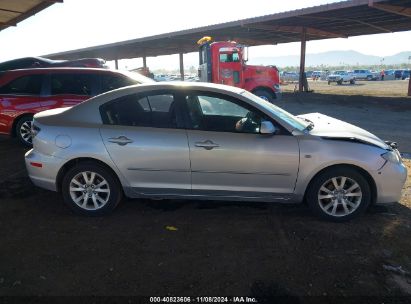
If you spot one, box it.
[185,94,266,134]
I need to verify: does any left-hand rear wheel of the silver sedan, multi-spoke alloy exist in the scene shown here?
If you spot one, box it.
[62,162,122,216]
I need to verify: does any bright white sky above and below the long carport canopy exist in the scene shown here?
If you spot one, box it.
[0,0,411,68]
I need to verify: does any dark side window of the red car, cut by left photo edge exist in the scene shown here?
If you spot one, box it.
[0,75,43,95]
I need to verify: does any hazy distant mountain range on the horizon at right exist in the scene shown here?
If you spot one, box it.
[248,51,411,67]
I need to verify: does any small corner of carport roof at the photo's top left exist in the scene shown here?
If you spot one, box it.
[0,0,63,31]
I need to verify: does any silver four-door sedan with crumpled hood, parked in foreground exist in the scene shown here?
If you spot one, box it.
[25,83,407,221]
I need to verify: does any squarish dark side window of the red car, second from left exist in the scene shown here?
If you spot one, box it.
[50,74,93,96]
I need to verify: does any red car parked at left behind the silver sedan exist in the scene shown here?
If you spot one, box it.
[0,68,153,146]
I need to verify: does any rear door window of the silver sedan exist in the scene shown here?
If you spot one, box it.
[100,94,177,128]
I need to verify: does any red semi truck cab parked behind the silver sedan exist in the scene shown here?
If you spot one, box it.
[197,37,281,102]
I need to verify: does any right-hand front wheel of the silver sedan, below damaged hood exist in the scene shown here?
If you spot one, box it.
[307,167,371,222]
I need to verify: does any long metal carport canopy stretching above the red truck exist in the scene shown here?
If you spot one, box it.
[44,0,411,60]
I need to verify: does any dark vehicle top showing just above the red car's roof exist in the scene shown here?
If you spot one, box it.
[0,57,108,71]
